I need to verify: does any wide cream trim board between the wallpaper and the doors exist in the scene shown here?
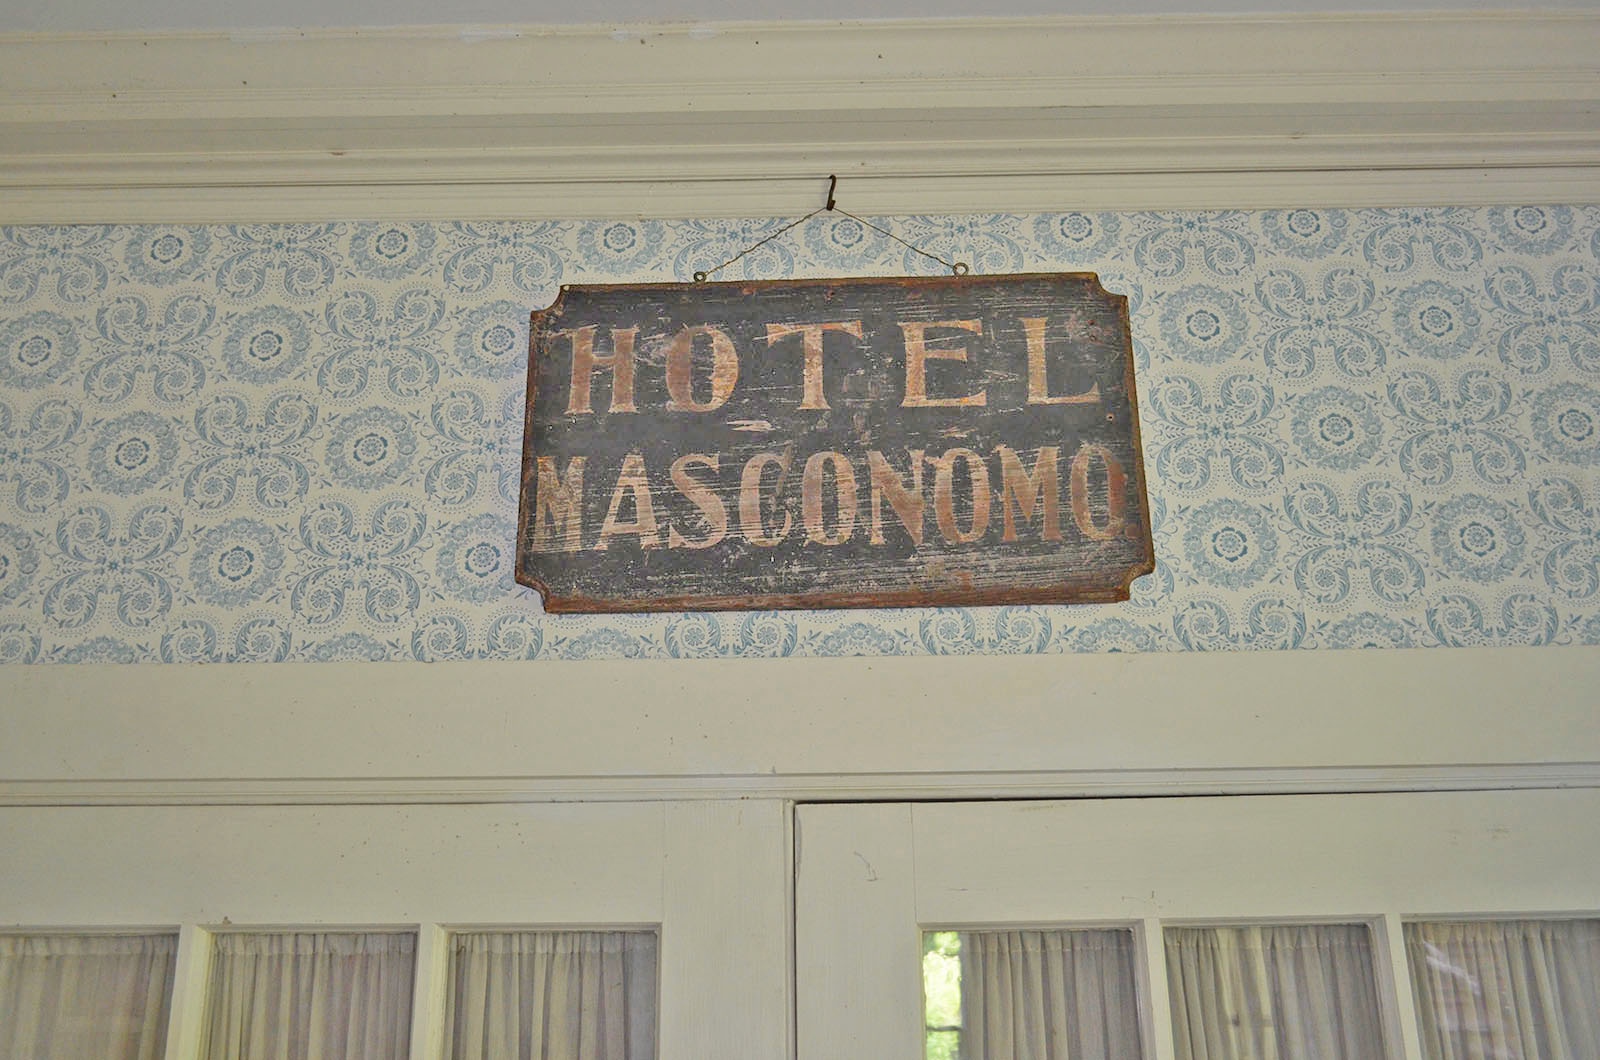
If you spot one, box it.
[0,648,1600,807]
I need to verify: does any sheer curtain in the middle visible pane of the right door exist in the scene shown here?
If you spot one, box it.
[1166,924,1386,1060]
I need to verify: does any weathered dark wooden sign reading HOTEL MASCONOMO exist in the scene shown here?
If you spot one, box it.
[517,274,1155,612]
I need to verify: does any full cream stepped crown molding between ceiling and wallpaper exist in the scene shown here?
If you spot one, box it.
[0,11,1600,223]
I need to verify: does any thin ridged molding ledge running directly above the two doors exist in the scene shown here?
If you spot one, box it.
[0,762,1600,807]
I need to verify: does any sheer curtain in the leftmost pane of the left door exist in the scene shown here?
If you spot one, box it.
[0,935,178,1060]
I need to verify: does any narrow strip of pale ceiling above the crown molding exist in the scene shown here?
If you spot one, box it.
[0,0,1600,32]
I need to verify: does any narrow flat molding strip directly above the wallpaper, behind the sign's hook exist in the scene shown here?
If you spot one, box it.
[9,165,1600,224]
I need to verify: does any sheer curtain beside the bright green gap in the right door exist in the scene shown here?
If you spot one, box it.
[962,930,1144,1060]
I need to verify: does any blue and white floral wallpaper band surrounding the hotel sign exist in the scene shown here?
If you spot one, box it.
[0,205,1600,665]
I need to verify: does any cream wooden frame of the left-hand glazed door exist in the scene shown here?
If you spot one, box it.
[0,801,790,1060]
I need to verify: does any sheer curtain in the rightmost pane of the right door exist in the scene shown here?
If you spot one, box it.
[1405,921,1600,1060]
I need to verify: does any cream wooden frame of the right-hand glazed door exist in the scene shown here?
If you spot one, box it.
[795,789,1600,1060]
